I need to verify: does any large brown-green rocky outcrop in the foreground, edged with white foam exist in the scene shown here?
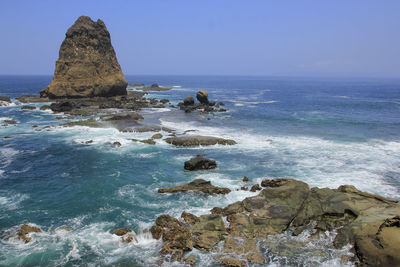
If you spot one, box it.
[151,179,400,266]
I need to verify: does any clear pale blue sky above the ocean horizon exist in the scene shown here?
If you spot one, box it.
[0,0,400,77]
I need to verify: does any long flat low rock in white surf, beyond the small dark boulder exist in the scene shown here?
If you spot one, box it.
[164,135,236,147]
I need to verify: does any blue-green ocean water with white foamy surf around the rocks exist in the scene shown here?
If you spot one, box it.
[0,76,400,266]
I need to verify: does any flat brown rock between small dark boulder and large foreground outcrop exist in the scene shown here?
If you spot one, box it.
[158,179,231,194]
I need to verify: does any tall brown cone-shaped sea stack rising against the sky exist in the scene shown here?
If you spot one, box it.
[40,16,128,98]
